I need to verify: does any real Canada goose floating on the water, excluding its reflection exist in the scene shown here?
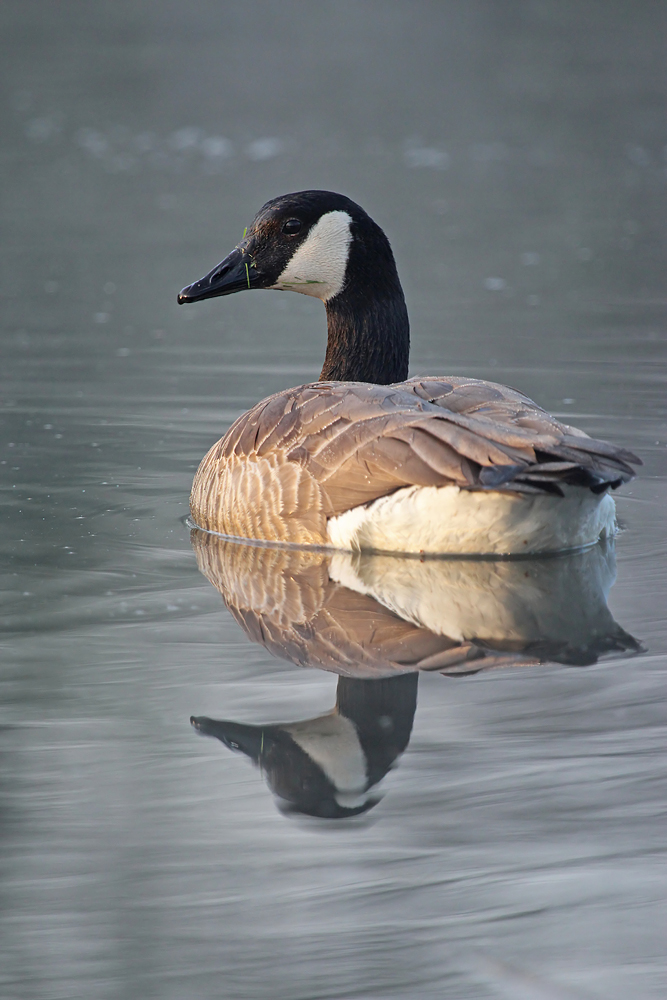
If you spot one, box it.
[178,191,641,555]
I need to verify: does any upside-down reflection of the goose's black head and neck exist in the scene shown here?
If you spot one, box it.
[190,673,418,819]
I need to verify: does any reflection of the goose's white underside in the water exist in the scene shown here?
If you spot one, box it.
[329,545,616,649]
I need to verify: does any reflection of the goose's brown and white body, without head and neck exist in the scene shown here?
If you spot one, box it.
[192,531,638,677]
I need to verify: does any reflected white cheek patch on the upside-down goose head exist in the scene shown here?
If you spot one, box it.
[284,713,367,795]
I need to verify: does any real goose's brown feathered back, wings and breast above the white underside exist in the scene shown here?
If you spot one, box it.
[191,377,640,545]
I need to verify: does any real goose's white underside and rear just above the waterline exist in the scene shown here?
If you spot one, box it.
[327,486,616,555]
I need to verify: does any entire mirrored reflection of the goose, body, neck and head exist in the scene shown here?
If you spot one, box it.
[191,531,640,818]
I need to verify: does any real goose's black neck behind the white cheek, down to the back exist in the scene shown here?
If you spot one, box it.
[320,216,410,385]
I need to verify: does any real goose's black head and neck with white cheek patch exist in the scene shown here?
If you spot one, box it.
[178,191,410,384]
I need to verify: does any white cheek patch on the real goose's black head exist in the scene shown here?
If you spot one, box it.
[271,212,352,302]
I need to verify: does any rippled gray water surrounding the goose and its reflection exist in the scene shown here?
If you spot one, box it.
[0,0,667,1000]
